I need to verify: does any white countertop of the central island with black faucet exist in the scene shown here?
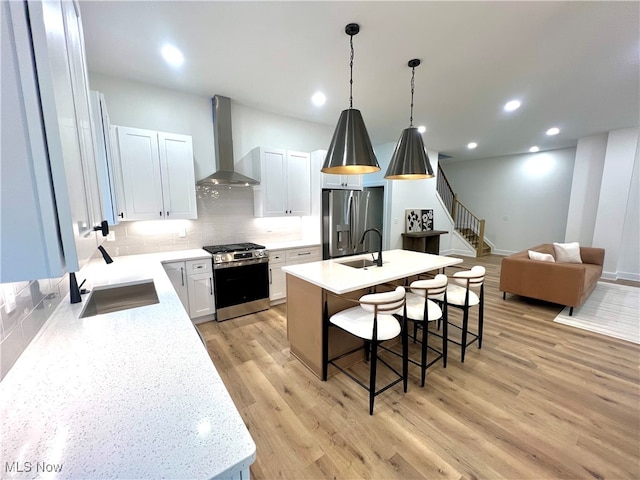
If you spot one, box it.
[282,250,462,295]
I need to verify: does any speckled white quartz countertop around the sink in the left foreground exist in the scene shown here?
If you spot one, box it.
[0,249,256,479]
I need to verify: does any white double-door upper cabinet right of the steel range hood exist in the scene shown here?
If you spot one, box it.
[238,147,311,217]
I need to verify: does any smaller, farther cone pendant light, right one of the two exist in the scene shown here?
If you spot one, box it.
[384,58,435,180]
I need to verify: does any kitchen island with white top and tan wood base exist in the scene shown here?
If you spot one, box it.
[283,250,462,378]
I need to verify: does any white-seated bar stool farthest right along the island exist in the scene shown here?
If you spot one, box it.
[447,265,485,363]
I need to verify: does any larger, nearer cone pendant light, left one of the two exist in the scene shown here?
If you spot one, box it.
[322,23,380,175]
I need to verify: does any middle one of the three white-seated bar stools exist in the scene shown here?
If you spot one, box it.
[382,274,448,387]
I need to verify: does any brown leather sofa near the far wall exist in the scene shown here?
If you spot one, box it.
[500,243,604,315]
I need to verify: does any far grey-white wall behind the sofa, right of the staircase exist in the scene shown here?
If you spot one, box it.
[442,148,575,255]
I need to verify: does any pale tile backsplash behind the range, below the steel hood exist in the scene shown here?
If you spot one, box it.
[104,186,320,256]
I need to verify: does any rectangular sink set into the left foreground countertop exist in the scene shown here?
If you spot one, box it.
[80,279,159,318]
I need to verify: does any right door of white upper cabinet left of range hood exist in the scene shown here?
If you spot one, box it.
[158,132,198,220]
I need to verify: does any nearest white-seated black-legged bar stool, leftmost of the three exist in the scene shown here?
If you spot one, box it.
[323,287,408,415]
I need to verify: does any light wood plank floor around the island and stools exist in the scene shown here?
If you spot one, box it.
[199,255,640,479]
